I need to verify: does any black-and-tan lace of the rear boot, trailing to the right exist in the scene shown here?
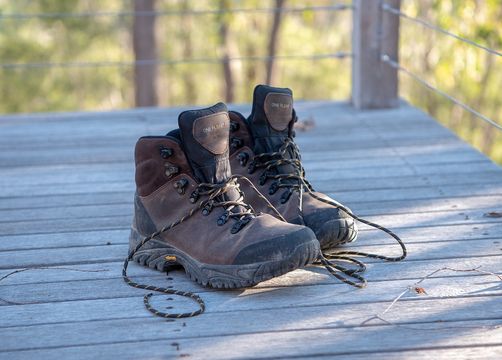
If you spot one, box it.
[250,137,407,288]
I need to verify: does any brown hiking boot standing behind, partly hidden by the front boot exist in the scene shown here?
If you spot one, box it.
[230,85,357,251]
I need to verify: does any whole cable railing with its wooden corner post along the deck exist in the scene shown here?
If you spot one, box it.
[0,0,502,134]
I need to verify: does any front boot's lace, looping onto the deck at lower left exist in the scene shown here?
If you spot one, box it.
[122,175,285,319]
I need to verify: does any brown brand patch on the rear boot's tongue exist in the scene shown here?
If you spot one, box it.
[263,93,293,131]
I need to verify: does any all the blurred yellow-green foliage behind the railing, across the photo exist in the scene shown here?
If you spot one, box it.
[0,0,502,164]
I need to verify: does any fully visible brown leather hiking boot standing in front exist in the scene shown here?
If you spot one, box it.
[126,103,319,290]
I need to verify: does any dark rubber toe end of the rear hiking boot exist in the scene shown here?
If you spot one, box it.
[312,217,357,251]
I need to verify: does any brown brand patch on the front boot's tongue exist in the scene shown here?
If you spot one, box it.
[193,112,230,155]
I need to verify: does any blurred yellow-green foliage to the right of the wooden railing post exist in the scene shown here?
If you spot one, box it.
[400,0,502,164]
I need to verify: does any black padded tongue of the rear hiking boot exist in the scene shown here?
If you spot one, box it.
[248,85,293,154]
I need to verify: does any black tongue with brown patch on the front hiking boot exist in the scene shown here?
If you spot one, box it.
[178,103,231,183]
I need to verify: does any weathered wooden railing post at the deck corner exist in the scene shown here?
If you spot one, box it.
[352,0,400,109]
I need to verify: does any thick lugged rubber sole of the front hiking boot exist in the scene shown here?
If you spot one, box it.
[129,228,320,289]
